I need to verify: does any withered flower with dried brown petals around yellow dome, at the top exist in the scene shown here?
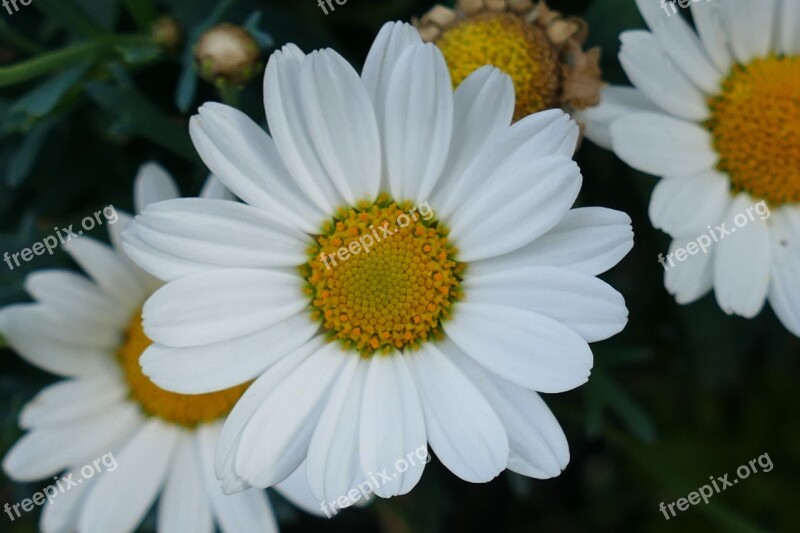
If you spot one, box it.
[415,0,603,120]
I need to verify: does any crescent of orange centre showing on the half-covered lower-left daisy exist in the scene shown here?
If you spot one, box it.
[117,312,249,427]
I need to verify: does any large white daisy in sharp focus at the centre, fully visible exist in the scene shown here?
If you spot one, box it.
[124,23,633,508]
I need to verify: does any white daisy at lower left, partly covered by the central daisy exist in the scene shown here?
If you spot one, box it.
[0,164,319,533]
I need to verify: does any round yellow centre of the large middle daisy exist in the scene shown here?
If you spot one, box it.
[302,196,463,356]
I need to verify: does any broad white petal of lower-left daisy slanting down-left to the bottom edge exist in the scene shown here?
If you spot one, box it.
[80,418,179,533]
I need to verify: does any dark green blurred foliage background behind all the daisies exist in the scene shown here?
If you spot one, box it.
[0,0,800,533]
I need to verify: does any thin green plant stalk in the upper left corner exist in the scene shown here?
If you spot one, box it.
[0,35,151,87]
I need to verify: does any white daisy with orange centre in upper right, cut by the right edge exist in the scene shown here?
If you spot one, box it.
[582,0,800,336]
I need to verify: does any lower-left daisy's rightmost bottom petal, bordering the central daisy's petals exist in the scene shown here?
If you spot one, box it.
[195,424,278,533]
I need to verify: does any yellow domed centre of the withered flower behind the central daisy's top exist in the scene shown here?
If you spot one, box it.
[436,13,561,120]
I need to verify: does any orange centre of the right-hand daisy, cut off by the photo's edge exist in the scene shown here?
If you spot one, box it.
[706,56,800,206]
